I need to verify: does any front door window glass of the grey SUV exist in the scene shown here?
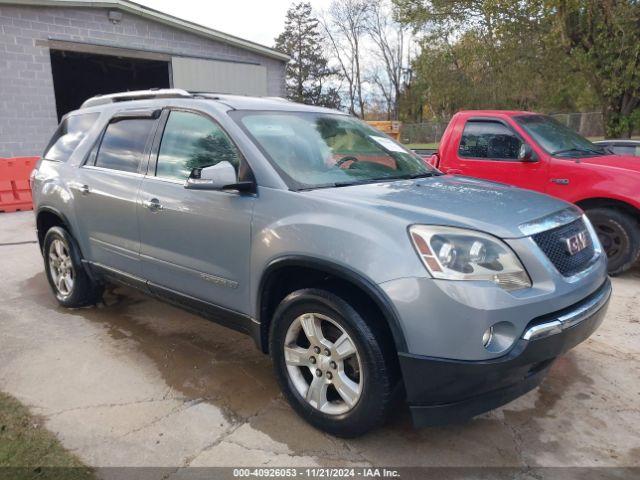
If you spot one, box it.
[156,111,240,180]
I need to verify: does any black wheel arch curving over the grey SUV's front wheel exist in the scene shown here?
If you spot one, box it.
[256,255,407,353]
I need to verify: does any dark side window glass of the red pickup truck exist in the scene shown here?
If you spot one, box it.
[458,120,522,160]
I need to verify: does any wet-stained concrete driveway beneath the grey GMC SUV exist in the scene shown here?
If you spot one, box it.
[0,212,640,467]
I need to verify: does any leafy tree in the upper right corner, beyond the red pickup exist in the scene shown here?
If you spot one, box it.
[552,0,640,138]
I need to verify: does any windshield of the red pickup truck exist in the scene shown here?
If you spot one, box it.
[515,115,606,157]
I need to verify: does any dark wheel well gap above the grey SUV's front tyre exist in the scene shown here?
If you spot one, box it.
[259,265,398,362]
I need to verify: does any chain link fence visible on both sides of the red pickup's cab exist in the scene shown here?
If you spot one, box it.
[400,112,604,145]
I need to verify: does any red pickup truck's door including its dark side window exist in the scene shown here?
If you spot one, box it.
[444,118,546,191]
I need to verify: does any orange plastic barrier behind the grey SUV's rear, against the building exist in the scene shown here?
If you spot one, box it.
[0,157,38,212]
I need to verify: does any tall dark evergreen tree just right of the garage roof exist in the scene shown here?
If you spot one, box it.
[275,2,340,108]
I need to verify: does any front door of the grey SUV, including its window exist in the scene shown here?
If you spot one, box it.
[139,110,255,313]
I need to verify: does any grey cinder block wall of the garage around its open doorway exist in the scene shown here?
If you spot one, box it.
[0,5,284,157]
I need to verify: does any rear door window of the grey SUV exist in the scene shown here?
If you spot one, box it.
[95,118,155,172]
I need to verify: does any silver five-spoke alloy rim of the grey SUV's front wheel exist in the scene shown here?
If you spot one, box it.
[284,313,364,415]
